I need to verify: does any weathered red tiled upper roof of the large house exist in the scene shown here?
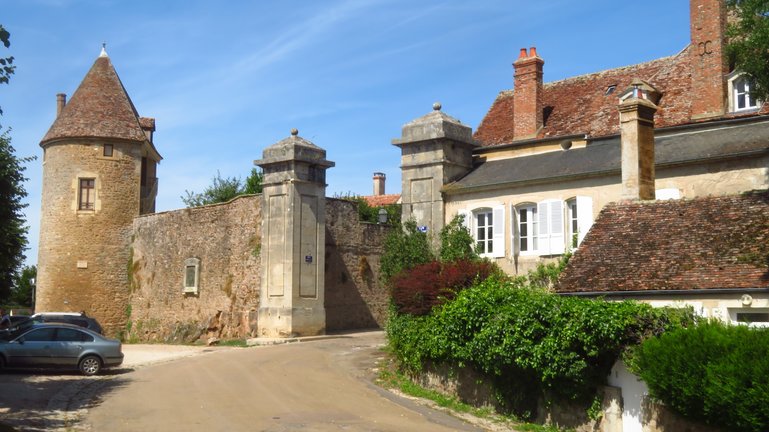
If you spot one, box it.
[475,48,769,146]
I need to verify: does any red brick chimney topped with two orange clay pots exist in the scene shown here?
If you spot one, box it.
[513,47,545,140]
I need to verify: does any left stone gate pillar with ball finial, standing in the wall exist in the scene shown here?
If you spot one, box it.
[254,129,334,337]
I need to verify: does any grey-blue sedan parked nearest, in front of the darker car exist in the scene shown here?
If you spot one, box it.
[0,323,123,376]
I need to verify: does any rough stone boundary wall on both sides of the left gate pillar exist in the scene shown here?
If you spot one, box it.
[123,195,392,343]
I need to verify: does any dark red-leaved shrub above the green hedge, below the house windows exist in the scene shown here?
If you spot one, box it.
[391,260,501,315]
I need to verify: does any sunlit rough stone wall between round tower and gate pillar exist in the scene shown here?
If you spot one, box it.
[125,195,262,343]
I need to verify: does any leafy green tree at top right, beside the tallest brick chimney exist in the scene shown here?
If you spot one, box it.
[726,0,769,101]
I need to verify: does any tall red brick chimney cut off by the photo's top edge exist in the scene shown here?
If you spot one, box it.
[689,0,729,120]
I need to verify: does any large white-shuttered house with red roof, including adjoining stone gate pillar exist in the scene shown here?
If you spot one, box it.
[393,0,769,274]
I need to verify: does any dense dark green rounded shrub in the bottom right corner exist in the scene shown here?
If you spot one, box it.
[633,322,769,431]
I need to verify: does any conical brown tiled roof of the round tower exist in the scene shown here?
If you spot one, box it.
[40,51,147,145]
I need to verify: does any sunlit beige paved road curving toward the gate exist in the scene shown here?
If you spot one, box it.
[82,332,479,432]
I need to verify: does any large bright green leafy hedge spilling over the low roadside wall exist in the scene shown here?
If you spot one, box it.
[386,278,692,409]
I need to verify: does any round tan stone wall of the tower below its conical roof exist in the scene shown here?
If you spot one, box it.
[36,141,141,335]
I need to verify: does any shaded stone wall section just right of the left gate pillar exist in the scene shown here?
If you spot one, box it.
[326,198,392,332]
